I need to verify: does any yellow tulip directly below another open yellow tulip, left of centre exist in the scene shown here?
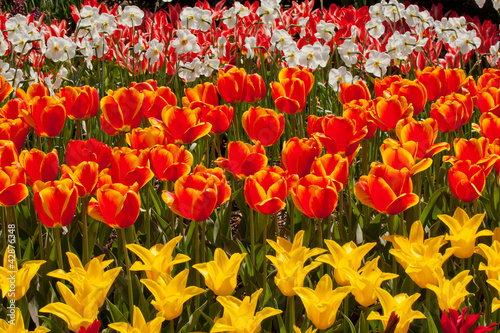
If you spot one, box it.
[141,269,205,320]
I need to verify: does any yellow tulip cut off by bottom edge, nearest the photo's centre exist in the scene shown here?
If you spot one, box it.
[210,289,281,333]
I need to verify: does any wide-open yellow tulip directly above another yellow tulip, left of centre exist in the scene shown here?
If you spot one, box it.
[127,236,191,281]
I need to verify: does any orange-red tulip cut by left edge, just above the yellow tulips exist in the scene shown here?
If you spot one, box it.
[0,165,28,207]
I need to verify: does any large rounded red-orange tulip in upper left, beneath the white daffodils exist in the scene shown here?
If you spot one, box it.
[100,87,145,132]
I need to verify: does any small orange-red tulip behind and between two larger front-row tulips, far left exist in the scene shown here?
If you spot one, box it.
[61,161,99,198]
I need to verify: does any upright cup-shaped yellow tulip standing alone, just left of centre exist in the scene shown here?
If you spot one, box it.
[193,248,246,296]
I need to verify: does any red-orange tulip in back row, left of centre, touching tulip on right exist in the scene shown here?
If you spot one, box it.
[217,65,247,104]
